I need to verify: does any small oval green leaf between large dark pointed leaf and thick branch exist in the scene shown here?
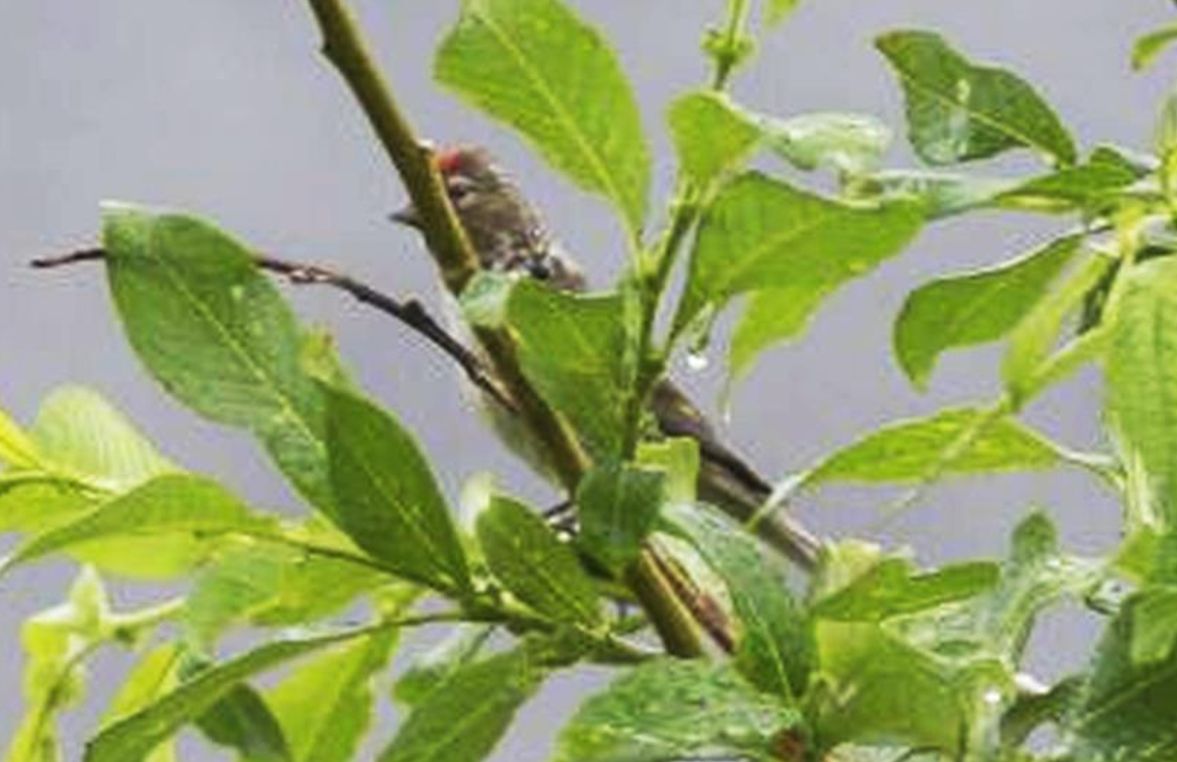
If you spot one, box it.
[477,496,601,627]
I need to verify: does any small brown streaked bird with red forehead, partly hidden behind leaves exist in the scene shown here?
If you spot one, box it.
[392,146,820,569]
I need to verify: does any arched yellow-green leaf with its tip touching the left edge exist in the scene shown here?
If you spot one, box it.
[0,475,274,576]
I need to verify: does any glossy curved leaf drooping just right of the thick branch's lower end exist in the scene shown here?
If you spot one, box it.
[665,504,813,698]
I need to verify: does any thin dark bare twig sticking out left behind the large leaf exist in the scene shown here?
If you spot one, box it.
[29,249,517,411]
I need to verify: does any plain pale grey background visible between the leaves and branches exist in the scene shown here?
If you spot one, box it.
[0,0,1173,762]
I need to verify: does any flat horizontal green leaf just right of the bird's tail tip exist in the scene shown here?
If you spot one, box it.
[813,558,999,622]
